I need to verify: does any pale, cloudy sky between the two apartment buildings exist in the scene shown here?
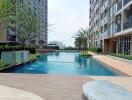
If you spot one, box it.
[48,0,89,46]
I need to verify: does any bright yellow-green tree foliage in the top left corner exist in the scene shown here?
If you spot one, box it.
[0,0,16,36]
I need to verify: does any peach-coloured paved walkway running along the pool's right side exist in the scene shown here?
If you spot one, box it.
[89,52,132,76]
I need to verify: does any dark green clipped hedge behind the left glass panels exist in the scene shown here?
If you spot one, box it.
[0,46,36,54]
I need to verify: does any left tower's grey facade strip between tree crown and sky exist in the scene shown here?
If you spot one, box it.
[24,0,48,47]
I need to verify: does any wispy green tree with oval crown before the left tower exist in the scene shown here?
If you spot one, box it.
[16,3,37,45]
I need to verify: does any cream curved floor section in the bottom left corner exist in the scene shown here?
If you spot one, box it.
[0,85,44,100]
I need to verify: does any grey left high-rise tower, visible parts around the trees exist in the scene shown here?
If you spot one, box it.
[2,0,48,46]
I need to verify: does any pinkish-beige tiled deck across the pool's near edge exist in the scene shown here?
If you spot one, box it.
[0,73,132,100]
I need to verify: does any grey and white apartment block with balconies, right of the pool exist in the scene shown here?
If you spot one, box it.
[88,0,132,54]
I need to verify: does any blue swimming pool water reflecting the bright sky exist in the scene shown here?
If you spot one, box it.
[8,52,116,76]
